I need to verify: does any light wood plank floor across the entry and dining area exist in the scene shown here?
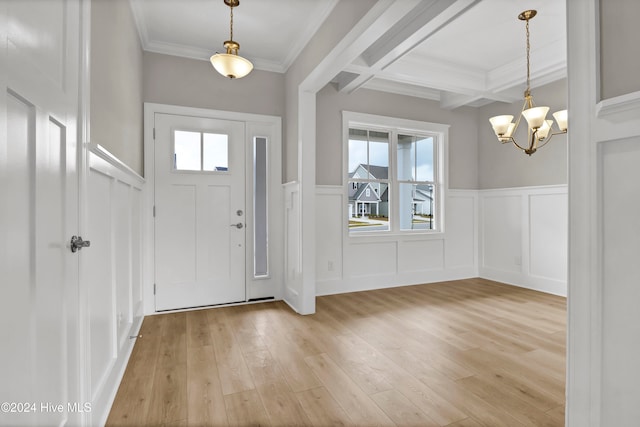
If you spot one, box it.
[107,279,566,427]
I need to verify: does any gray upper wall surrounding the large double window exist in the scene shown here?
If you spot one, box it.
[316,84,478,189]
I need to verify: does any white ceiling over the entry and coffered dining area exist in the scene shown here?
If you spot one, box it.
[130,0,566,109]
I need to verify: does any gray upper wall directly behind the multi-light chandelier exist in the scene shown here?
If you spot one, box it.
[478,79,571,189]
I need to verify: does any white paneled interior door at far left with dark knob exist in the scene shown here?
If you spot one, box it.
[0,0,80,426]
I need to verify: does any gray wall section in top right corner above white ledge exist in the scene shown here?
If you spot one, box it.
[600,0,640,99]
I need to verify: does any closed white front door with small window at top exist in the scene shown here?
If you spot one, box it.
[154,113,246,311]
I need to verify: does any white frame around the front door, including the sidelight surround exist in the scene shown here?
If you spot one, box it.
[143,103,284,314]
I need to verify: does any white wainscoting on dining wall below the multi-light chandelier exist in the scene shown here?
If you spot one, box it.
[479,185,568,296]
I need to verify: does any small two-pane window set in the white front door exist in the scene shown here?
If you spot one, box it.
[173,130,229,172]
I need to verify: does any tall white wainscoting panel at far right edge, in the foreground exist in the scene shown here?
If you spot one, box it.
[598,137,640,426]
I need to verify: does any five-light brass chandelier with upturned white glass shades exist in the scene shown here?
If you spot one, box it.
[489,10,567,156]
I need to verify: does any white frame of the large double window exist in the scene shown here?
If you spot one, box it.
[342,111,450,239]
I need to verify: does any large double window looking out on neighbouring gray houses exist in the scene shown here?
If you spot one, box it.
[344,112,448,235]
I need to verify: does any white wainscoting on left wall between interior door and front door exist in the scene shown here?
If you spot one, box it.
[81,145,144,425]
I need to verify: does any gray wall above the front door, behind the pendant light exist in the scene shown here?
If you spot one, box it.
[144,52,285,117]
